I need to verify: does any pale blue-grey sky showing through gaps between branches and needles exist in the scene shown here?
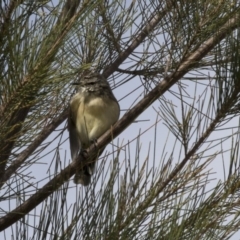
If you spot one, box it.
[0,0,240,240]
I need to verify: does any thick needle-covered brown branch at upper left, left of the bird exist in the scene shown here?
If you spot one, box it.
[0,0,80,176]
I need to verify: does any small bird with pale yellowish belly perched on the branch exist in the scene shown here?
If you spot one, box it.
[68,73,120,186]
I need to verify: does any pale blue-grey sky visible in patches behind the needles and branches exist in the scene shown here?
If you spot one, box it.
[0,0,240,240]
